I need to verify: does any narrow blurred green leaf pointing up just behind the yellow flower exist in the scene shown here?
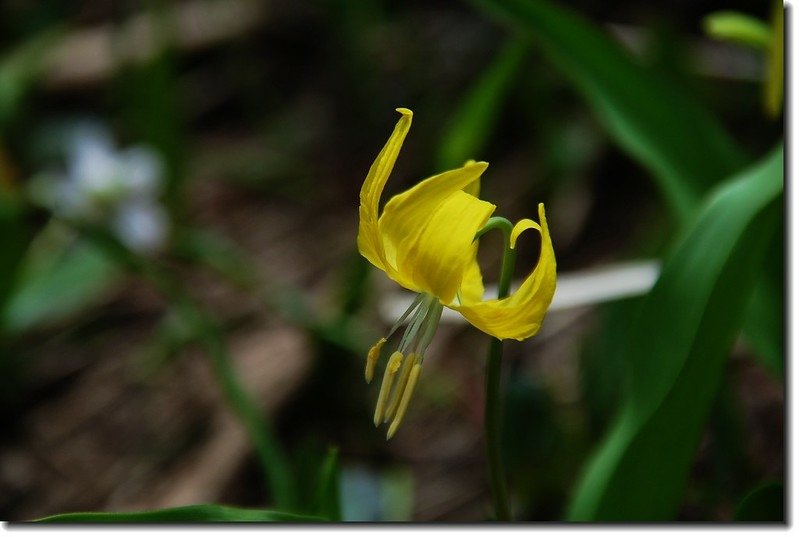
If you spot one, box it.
[436,38,529,170]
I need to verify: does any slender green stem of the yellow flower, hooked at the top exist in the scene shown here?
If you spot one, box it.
[476,217,516,520]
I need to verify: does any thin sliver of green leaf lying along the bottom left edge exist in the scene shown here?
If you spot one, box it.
[35,504,325,524]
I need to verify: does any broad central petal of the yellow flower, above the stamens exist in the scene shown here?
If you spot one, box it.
[396,190,495,304]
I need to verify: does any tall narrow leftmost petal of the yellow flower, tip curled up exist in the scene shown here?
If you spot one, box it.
[358,108,413,270]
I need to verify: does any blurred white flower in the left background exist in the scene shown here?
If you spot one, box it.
[31,123,169,253]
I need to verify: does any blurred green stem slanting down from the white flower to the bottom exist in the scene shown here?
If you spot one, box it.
[75,225,298,509]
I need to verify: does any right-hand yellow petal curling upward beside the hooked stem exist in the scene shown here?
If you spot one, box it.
[450,204,557,340]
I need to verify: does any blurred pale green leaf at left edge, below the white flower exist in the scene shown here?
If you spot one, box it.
[2,233,120,332]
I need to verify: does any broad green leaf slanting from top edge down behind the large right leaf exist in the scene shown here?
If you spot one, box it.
[471,0,745,222]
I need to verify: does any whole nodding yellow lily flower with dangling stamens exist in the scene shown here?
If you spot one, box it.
[358,108,556,438]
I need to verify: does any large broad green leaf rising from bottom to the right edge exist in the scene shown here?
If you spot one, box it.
[569,146,783,520]
